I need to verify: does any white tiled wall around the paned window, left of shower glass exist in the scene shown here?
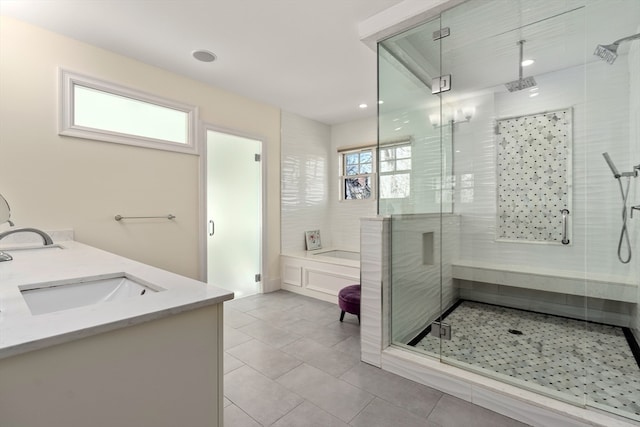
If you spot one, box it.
[329,116,378,251]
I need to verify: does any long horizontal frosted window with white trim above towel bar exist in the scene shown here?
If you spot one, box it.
[59,70,198,154]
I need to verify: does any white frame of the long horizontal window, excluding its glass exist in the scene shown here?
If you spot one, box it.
[58,68,200,155]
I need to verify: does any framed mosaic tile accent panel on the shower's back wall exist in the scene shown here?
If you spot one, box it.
[496,109,572,243]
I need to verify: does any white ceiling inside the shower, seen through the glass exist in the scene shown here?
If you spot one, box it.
[380,0,640,111]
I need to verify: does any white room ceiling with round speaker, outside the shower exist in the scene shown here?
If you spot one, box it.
[0,0,402,124]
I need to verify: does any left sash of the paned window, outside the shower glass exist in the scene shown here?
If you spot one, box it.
[339,147,375,200]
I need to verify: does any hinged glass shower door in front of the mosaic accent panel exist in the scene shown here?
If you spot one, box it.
[441,0,586,405]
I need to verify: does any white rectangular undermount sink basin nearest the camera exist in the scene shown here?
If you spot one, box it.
[19,273,164,314]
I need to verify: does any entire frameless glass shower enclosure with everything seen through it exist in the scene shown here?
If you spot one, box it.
[378,0,640,420]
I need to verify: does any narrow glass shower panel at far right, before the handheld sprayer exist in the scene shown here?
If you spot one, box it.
[579,0,640,421]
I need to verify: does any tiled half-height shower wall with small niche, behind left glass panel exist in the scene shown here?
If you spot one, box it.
[391,214,459,344]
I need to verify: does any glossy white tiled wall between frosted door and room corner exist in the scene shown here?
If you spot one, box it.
[280,112,332,252]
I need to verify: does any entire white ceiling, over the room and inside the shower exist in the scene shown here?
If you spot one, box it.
[0,0,640,125]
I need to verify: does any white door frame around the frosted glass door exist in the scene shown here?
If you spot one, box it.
[198,123,267,293]
